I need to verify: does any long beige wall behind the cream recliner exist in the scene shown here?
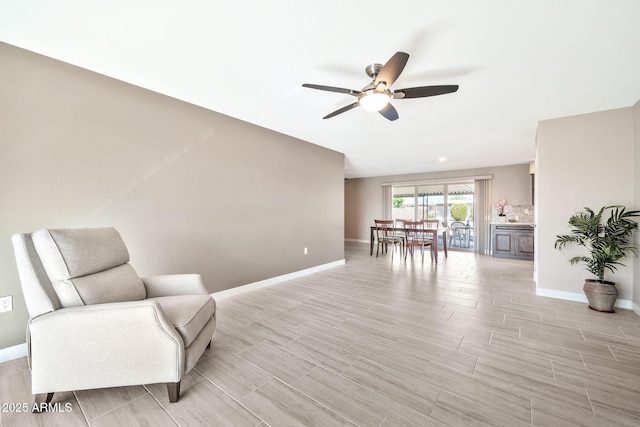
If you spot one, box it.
[0,44,344,349]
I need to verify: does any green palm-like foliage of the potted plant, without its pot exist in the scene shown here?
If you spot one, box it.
[555,205,640,282]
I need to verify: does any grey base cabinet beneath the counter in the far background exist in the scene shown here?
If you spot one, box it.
[491,223,533,260]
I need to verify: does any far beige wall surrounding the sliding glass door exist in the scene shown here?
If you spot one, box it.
[344,163,531,241]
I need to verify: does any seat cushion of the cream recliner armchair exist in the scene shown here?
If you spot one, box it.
[149,294,216,348]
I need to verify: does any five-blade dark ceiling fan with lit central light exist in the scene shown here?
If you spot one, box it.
[302,52,458,120]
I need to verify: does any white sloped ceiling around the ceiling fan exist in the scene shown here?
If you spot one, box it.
[0,0,640,178]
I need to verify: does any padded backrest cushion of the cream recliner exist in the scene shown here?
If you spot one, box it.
[32,227,146,307]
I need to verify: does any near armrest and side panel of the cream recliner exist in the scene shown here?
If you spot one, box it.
[29,300,185,394]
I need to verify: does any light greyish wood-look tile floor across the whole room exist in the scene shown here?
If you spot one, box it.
[0,243,640,427]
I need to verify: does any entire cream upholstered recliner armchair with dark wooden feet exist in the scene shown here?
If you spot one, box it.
[12,228,216,410]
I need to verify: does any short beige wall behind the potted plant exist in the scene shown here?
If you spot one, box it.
[536,107,638,301]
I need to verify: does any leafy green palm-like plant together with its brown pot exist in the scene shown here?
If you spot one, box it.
[554,205,640,313]
